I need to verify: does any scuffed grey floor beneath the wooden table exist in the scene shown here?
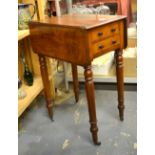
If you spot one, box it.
[18,86,137,155]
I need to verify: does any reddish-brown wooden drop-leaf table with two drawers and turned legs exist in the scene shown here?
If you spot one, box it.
[29,14,127,145]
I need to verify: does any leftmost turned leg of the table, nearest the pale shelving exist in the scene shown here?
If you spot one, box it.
[38,55,53,119]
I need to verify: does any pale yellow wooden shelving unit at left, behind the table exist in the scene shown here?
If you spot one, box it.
[18,0,55,117]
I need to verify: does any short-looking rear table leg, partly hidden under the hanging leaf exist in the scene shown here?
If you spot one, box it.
[72,64,79,102]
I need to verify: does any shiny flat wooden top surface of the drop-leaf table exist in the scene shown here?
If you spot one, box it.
[32,14,126,29]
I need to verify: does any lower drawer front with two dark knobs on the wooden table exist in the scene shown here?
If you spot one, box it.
[92,35,120,56]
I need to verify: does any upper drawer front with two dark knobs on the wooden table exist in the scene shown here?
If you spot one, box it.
[91,22,119,42]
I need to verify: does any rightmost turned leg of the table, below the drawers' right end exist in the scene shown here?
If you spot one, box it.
[115,50,125,121]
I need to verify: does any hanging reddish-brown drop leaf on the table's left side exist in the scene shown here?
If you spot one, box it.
[30,23,90,65]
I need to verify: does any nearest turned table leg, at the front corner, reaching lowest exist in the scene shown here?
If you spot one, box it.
[84,66,101,145]
